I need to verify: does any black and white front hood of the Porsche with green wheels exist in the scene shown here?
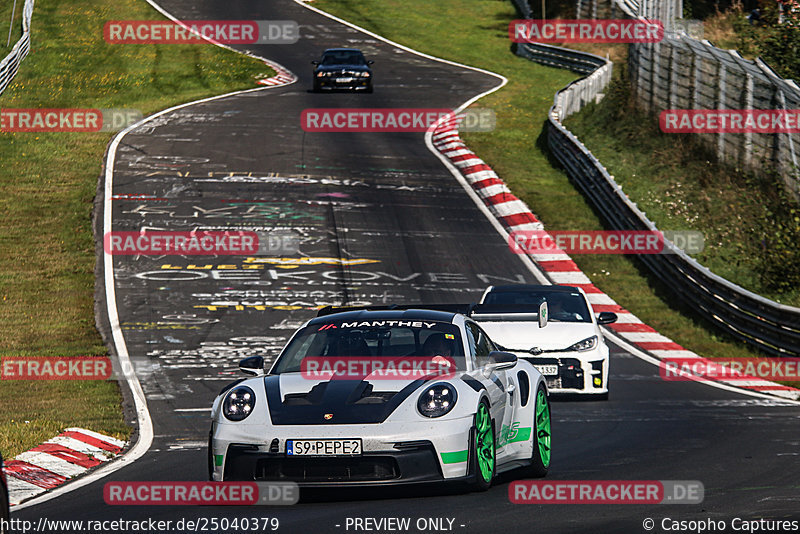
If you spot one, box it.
[264,373,424,425]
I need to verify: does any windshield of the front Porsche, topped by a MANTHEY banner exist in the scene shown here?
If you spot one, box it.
[271,319,466,374]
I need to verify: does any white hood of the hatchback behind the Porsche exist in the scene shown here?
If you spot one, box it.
[480,321,597,351]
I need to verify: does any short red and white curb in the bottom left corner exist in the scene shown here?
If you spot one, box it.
[4,428,127,506]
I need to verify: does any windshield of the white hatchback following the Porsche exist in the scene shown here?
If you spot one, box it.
[480,290,592,323]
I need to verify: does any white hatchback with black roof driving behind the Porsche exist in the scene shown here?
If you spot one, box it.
[470,284,617,400]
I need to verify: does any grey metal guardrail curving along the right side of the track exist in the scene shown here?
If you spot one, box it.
[517,44,800,357]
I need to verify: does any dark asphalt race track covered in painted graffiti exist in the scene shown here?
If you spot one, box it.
[14,0,800,533]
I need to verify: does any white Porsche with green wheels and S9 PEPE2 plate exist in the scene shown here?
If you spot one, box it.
[209,307,550,490]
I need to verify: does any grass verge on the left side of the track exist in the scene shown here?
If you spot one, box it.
[0,0,272,457]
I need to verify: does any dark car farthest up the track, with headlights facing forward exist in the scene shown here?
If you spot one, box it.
[311,48,373,93]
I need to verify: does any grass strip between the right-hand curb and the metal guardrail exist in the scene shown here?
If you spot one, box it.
[314,0,768,364]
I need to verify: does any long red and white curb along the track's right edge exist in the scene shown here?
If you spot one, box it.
[431,115,800,400]
